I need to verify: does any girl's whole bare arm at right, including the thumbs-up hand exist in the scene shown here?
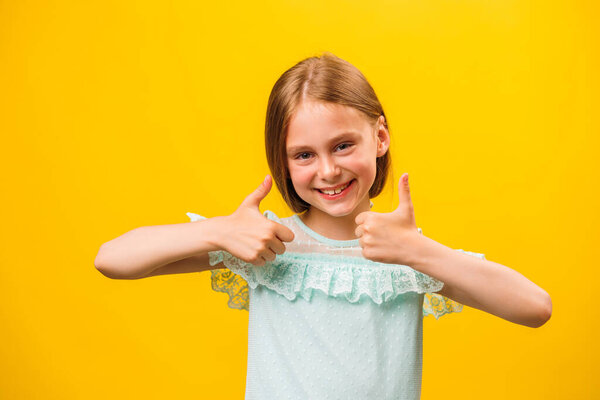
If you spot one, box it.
[355,173,552,328]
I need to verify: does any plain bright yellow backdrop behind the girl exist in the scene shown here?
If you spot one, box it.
[0,0,600,400]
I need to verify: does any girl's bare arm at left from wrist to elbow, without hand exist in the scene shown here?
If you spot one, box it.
[94,217,226,279]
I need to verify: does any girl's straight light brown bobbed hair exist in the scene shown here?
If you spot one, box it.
[265,52,392,213]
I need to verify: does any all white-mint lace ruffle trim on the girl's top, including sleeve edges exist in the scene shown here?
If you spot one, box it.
[187,210,485,319]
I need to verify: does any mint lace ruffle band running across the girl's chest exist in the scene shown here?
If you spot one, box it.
[209,251,444,304]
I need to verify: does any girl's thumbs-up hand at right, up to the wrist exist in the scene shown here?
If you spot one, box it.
[354,173,421,266]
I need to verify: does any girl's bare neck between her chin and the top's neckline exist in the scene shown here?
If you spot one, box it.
[299,197,371,240]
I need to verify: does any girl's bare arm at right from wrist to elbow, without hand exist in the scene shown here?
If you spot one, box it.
[410,235,552,328]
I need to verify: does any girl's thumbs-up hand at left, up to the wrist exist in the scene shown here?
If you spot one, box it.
[220,175,294,266]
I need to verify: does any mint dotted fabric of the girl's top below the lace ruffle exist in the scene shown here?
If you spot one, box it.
[246,285,423,400]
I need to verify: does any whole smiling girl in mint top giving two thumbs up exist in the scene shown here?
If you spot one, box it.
[95,53,552,399]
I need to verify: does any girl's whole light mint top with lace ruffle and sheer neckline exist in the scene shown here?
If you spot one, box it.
[188,211,484,400]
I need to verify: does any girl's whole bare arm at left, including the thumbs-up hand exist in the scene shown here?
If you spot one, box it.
[94,176,294,279]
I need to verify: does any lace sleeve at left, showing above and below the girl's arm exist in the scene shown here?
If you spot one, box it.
[187,210,279,311]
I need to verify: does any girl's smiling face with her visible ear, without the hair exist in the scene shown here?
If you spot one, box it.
[286,101,389,217]
